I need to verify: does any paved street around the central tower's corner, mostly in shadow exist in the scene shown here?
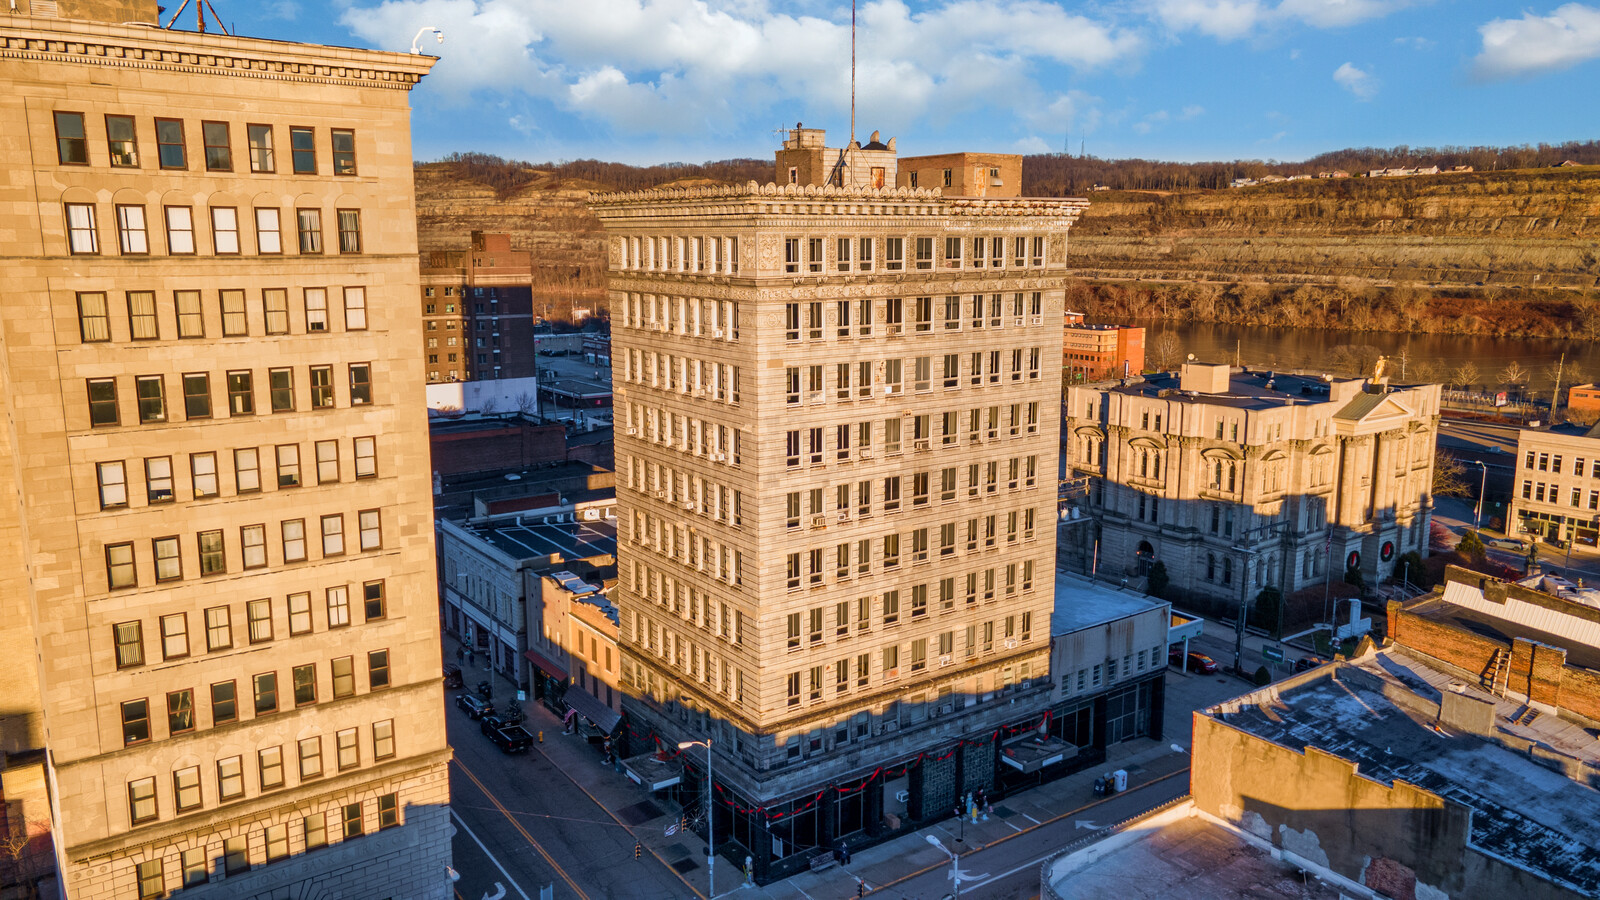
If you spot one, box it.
[446,633,1259,900]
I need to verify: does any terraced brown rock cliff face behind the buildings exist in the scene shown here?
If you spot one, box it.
[416,163,1600,335]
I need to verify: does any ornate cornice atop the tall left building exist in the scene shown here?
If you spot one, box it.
[0,18,437,91]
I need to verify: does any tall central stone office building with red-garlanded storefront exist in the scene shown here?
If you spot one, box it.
[592,128,1086,879]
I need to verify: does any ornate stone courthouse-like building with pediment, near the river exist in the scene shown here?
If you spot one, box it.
[1064,364,1438,612]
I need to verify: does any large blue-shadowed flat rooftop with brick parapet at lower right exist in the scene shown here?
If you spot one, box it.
[1202,649,1600,897]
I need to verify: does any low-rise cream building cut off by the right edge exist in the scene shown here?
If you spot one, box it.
[1506,424,1600,546]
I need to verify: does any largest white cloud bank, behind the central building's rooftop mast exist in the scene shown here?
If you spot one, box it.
[342,0,1142,135]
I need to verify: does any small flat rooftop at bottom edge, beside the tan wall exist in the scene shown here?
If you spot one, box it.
[1048,817,1344,900]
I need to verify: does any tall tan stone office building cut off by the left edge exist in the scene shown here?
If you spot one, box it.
[0,0,450,898]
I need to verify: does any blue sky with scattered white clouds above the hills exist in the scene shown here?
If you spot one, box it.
[222,0,1600,163]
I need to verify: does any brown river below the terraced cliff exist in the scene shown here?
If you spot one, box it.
[1117,320,1600,392]
